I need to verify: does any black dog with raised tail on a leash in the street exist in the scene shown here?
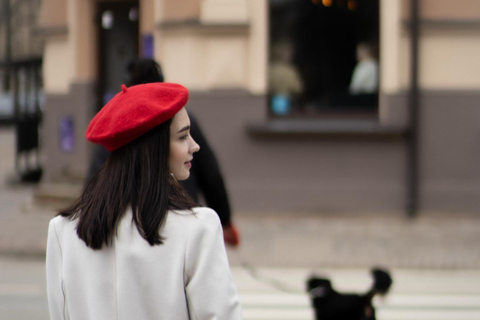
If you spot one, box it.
[307,269,392,320]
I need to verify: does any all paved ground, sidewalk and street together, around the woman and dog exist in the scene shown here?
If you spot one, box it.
[0,127,480,320]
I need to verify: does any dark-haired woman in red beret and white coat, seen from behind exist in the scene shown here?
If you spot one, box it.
[47,83,241,320]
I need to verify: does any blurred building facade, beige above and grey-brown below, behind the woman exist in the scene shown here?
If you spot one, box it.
[39,0,480,213]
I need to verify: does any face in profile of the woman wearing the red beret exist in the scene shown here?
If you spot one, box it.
[168,108,200,180]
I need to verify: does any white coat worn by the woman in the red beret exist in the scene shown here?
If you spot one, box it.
[46,208,241,320]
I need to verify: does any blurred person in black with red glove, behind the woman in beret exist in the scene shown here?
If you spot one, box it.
[86,58,240,247]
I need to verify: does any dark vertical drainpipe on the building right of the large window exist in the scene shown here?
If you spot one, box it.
[407,0,420,217]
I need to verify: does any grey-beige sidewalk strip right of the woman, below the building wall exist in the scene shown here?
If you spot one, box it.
[230,214,480,269]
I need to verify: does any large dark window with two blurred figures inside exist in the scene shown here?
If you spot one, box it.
[269,0,379,117]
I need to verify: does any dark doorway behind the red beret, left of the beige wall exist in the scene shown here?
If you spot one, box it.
[97,1,139,109]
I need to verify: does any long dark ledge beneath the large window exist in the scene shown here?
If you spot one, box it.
[246,120,407,140]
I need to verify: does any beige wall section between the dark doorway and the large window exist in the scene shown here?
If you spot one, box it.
[155,0,268,94]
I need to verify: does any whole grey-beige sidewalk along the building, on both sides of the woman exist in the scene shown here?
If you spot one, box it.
[0,128,480,269]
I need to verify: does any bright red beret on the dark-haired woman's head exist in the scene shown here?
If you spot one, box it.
[86,82,188,151]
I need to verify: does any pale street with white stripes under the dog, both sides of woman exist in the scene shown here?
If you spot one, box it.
[0,255,480,320]
